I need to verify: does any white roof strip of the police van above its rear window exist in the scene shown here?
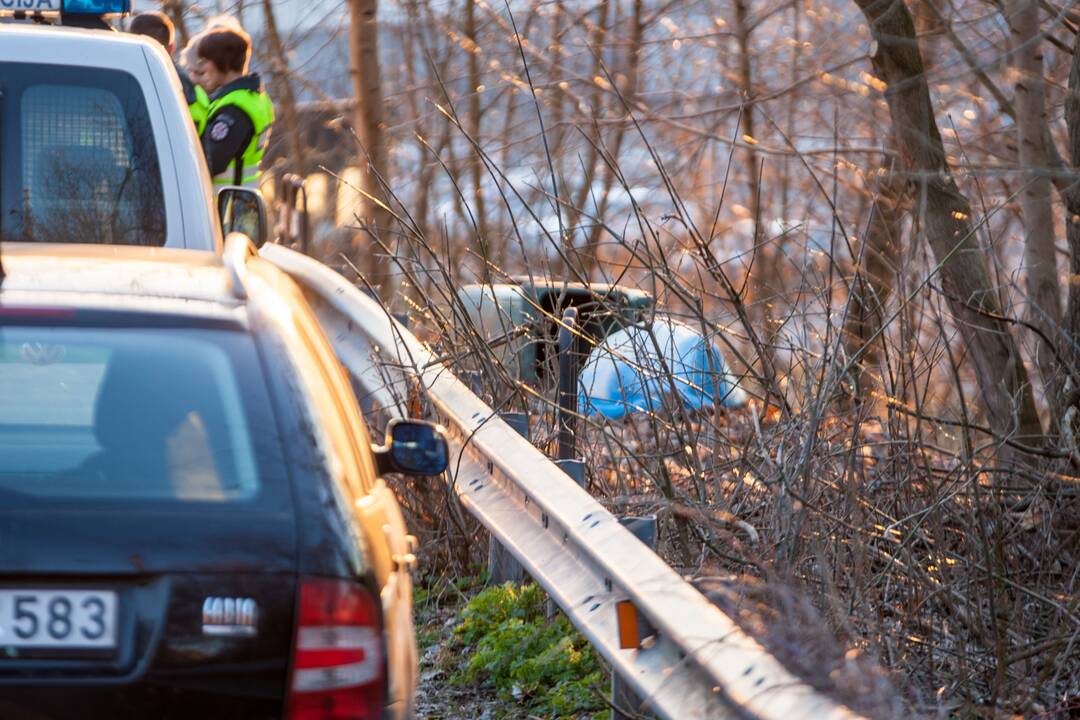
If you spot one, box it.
[0,23,156,69]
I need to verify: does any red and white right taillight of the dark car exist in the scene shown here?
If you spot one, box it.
[286,578,386,720]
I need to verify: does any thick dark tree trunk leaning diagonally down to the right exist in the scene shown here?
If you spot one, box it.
[855,0,1042,445]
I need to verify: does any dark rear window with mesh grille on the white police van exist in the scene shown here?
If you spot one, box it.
[0,63,165,245]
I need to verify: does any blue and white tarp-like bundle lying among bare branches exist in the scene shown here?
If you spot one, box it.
[578,315,746,420]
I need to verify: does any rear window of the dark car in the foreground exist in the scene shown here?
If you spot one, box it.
[0,325,282,504]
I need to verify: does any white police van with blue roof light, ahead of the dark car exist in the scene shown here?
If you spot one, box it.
[0,0,230,250]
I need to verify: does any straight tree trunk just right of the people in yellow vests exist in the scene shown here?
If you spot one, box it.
[349,0,396,300]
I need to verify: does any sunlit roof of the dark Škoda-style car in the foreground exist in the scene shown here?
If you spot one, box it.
[0,242,243,315]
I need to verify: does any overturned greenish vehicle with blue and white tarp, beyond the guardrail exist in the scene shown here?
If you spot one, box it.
[458,277,746,420]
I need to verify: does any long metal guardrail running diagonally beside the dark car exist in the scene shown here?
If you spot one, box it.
[261,245,859,720]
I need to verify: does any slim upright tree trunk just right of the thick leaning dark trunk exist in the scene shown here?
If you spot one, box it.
[1004,0,1066,423]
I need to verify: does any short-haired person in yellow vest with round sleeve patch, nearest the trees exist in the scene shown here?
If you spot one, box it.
[197,27,273,188]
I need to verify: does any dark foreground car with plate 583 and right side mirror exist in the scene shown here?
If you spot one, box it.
[0,237,446,720]
